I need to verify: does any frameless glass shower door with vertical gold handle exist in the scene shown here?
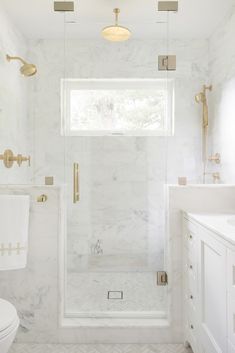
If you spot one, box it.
[61,9,174,319]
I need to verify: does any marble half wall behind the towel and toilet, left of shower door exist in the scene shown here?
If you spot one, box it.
[0,185,60,342]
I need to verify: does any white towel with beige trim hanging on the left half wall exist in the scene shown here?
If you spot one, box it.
[0,195,30,271]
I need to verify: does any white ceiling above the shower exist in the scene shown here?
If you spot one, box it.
[0,0,235,39]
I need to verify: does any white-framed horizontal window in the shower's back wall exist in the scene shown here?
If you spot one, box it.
[61,79,174,136]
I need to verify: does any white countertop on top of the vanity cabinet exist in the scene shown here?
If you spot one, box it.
[185,212,235,245]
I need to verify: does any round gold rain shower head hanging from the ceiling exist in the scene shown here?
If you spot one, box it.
[102,9,131,42]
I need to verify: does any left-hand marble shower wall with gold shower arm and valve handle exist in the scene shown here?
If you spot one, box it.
[0,8,32,184]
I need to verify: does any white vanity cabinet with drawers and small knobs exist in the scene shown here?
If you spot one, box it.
[183,214,235,353]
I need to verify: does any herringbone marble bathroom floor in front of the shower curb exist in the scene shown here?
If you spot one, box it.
[9,344,192,353]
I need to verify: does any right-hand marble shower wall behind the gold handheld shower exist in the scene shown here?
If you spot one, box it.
[209,9,235,183]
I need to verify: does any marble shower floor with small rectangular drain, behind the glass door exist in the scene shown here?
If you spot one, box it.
[66,272,166,314]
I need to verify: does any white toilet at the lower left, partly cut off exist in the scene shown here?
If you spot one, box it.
[0,299,20,353]
